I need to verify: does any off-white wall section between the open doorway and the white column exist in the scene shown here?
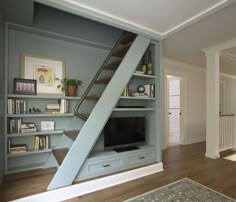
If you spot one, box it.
[162,58,206,144]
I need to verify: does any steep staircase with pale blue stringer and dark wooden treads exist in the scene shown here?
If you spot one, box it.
[48,32,150,190]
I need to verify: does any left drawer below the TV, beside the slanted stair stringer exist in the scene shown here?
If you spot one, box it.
[78,157,124,179]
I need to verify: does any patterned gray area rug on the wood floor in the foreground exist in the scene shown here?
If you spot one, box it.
[126,178,236,202]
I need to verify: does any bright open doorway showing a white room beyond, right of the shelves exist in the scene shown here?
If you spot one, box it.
[167,75,181,147]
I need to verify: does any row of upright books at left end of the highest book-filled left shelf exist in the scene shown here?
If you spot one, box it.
[7,98,26,114]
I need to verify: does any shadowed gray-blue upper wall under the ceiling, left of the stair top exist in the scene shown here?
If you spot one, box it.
[33,3,122,45]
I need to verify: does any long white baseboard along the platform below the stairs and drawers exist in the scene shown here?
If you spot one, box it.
[14,163,163,202]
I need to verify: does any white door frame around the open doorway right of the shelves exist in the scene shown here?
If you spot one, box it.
[163,69,187,149]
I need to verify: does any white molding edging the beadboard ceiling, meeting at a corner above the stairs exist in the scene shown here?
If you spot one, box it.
[35,0,232,40]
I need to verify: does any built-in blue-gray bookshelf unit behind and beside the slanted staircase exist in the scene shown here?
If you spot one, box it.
[4,24,160,182]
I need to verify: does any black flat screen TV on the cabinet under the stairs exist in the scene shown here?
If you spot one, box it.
[104,117,145,150]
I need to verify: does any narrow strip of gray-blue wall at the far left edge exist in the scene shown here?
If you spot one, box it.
[0,13,4,183]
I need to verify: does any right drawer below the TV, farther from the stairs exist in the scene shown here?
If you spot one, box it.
[127,149,155,168]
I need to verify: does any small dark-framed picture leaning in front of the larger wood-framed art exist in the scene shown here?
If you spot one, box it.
[14,78,37,95]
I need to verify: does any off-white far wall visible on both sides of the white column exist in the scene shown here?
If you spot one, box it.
[162,58,236,144]
